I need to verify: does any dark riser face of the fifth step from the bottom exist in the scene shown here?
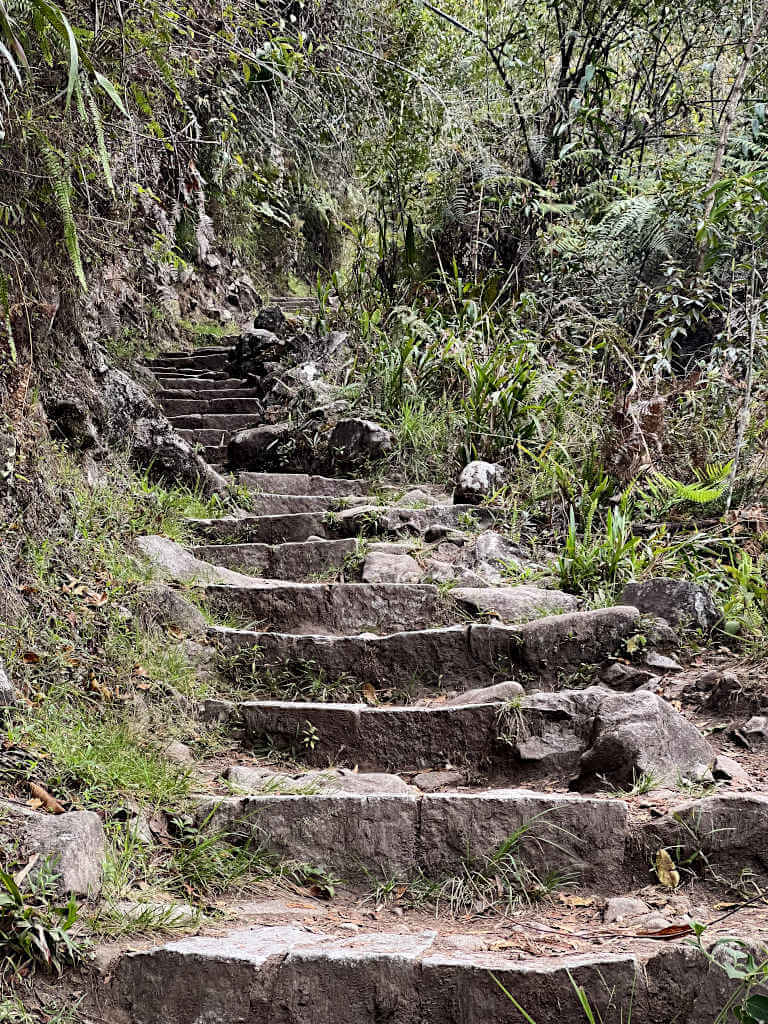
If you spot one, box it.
[206,584,448,635]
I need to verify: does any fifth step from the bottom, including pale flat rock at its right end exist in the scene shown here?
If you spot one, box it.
[205,582,578,635]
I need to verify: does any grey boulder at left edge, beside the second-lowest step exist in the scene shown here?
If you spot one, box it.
[0,801,105,897]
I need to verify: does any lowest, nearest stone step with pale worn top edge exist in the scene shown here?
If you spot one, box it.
[112,911,738,1024]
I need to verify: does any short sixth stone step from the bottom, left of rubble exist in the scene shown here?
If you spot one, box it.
[193,539,357,581]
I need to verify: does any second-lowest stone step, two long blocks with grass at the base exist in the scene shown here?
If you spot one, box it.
[196,790,629,888]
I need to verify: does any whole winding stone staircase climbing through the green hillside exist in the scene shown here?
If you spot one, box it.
[102,349,768,1024]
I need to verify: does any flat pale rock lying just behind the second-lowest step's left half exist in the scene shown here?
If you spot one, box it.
[226,765,417,796]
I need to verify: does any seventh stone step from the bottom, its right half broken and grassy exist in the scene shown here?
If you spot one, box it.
[187,501,493,544]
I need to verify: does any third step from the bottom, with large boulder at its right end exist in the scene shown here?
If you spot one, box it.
[236,686,716,792]
